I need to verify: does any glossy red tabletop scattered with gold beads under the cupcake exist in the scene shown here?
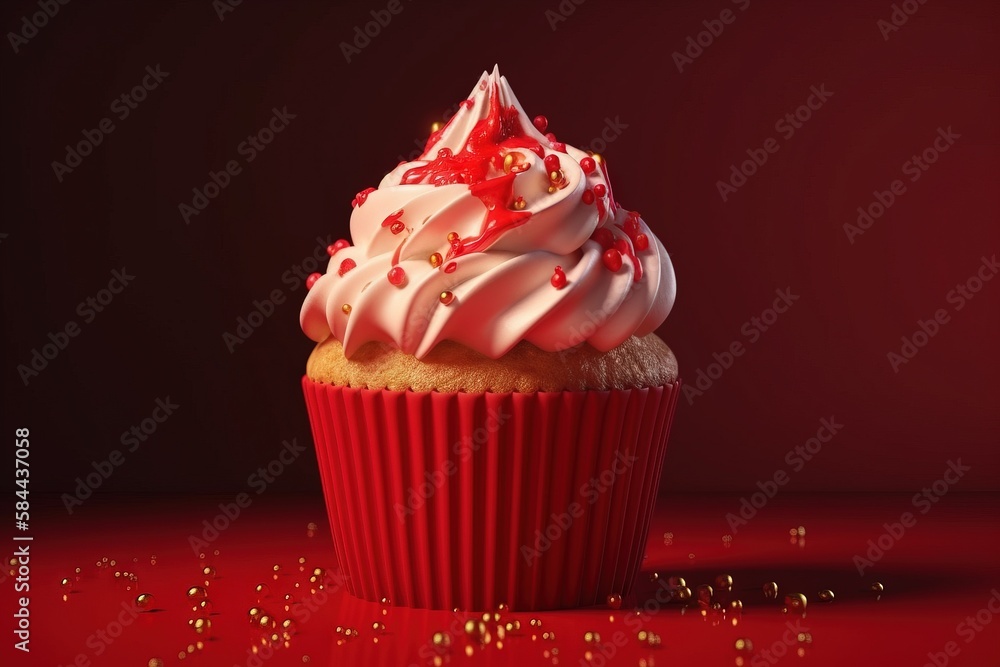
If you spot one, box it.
[0,494,1000,667]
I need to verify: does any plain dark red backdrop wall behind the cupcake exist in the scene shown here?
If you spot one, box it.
[0,0,1000,493]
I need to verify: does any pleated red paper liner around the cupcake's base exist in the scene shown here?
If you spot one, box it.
[302,377,680,611]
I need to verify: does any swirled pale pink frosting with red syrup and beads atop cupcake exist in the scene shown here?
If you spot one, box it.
[301,68,675,358]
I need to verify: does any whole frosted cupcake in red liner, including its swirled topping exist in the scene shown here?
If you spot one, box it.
[301,69,680,610]
